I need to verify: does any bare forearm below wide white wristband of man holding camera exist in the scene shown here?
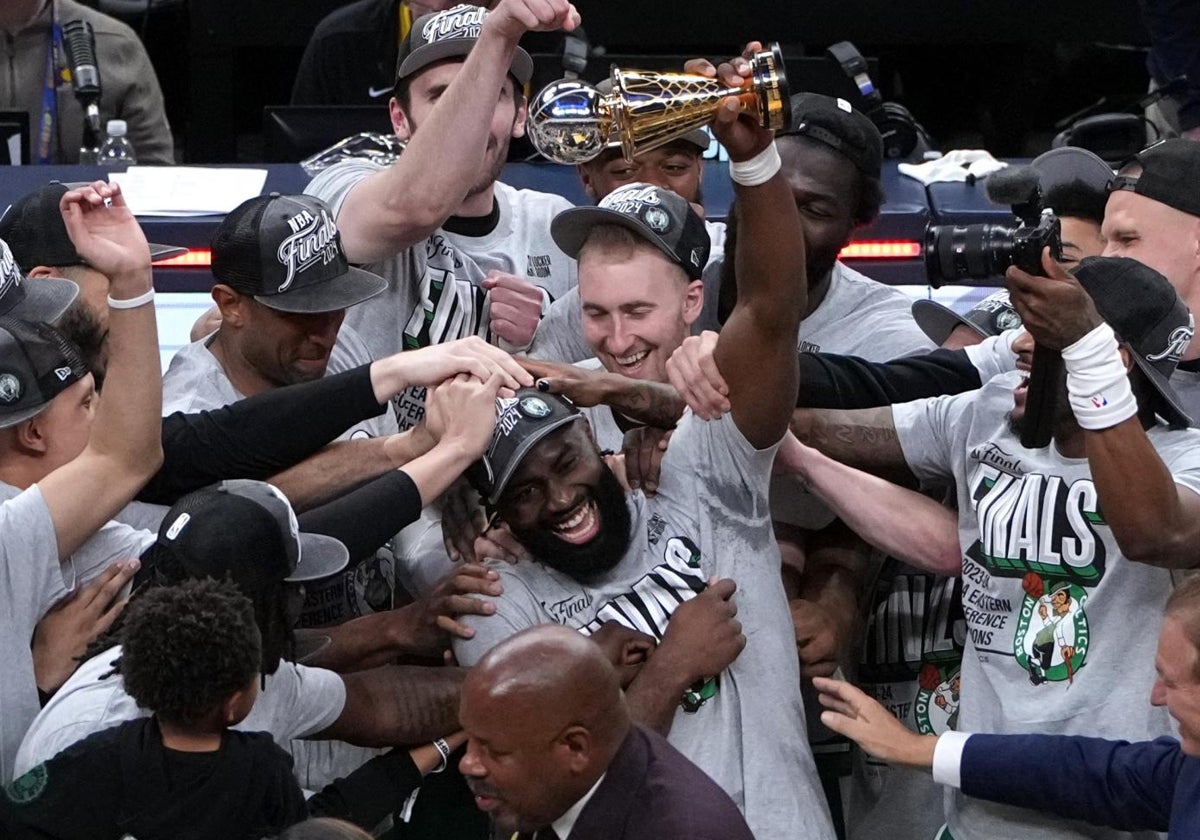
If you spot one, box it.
[1084,416,1200,569]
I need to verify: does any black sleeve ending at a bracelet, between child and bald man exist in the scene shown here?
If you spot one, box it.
[308,750,421,830]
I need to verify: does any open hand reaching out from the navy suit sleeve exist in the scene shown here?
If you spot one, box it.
[812,677,937,768]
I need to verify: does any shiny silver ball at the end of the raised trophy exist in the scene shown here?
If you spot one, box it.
[527,79,612,163]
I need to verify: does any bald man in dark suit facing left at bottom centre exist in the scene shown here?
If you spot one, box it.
[460,624,752,840]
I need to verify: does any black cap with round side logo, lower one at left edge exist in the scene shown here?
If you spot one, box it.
[0,317,88,428]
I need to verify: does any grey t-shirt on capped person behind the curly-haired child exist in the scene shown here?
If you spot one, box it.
[17,647,346,775]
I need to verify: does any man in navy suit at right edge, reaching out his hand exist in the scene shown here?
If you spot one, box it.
[814,577,1200,840]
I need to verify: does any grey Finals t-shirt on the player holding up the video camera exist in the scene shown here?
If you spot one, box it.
[892,373,1200,840]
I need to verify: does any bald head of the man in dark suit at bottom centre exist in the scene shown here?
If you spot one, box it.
[458,625,630,832]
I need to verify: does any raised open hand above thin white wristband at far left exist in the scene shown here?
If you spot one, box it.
[59,181,150,285]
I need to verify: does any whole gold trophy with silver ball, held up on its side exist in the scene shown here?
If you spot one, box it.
[528,43,792,163]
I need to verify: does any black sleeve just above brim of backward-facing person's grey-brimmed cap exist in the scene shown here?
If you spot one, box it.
[296,469,421,560]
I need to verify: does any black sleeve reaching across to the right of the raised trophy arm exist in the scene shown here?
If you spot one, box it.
[796,349,983,409]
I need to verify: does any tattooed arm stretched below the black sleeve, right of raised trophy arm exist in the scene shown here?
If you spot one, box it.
[792,406,916,485]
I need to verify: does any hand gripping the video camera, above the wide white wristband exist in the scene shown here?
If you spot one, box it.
[1004,248,1102,350]
